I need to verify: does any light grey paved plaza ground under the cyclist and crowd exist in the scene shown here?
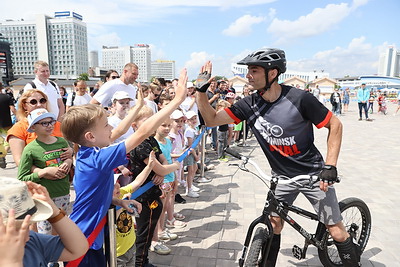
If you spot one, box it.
[0,102,400,267]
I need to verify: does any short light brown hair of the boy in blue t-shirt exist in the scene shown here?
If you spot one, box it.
[61,104,107,145]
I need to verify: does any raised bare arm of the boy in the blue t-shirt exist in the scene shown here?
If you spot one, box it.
[125,69,187,151]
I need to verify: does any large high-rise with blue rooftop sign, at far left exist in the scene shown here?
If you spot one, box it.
[0,11,89,78]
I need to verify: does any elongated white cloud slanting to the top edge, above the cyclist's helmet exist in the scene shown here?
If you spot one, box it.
[267,0,368,44]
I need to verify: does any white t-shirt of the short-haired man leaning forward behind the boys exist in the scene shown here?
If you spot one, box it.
[93,79,137,107]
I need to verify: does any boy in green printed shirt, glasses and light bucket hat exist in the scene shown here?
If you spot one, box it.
[18,108,72,234]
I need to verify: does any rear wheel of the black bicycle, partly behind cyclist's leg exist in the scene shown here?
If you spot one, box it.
[318,198,371,267]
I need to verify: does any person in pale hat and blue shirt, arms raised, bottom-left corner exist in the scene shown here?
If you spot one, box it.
[0,177,88,266]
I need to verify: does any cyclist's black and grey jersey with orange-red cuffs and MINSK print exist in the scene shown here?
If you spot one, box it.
[225,85,332,177]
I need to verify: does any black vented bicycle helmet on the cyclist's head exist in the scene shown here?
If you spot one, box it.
[237,48,286,73]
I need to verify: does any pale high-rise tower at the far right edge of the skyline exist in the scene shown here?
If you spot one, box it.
[378,45,400,77]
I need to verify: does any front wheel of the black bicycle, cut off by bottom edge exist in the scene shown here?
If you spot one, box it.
[244,227,268,267]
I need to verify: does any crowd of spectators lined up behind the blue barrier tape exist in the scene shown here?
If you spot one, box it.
[0,58,248,266]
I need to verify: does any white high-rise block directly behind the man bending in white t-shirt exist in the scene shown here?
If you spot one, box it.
[102,44,151,82]
